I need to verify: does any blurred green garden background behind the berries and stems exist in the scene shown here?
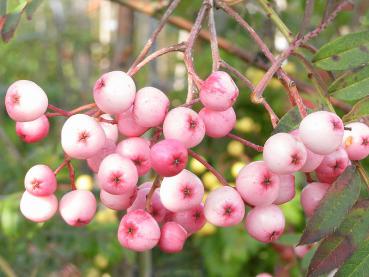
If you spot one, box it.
[0,0,369,277]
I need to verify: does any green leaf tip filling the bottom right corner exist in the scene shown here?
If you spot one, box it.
[334,239,369,277]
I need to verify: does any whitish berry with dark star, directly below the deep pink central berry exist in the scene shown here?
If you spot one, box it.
[160,169,204,212]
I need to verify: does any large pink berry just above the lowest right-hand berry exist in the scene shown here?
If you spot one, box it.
[236,161,280,206]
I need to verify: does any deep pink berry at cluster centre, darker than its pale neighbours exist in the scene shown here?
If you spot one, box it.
[150,139,188,177]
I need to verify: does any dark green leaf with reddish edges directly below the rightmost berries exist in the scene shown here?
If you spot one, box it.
[299,166,361,244]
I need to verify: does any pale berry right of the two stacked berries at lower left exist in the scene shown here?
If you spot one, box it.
[59,190,96,227]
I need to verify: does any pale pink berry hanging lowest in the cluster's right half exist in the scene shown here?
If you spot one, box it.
[245,205,285,243]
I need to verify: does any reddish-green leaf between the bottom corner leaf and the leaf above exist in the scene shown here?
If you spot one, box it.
[308,200,369,277]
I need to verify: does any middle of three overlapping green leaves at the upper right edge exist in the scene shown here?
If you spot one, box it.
[328,66,369,100]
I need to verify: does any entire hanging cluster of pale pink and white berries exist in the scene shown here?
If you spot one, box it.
[5,71,369,253]
